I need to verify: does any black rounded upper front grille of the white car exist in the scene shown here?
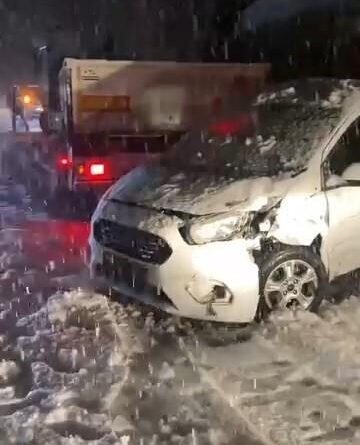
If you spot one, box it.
[94,219,172,264]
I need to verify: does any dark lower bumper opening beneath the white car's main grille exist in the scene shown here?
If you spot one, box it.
[100,252,175,307]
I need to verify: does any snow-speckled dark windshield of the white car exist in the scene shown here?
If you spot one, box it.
[162,103,339,179]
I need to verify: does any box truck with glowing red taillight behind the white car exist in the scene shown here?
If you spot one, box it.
[5,58,270,217]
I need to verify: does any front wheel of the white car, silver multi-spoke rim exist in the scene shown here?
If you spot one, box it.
[257,247,327,319]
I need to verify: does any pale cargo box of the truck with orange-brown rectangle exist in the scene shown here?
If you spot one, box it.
[59,59,270,133]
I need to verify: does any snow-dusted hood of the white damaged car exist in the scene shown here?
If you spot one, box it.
[107,166,294,216]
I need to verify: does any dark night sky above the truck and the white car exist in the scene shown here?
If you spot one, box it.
[0,0,360,89]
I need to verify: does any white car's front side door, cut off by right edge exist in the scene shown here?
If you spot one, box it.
[322,118,360,278]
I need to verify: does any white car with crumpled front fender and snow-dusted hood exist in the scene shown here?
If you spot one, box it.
[90,79,360,323]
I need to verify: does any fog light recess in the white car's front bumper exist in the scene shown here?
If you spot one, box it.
[185,278,233,305]
